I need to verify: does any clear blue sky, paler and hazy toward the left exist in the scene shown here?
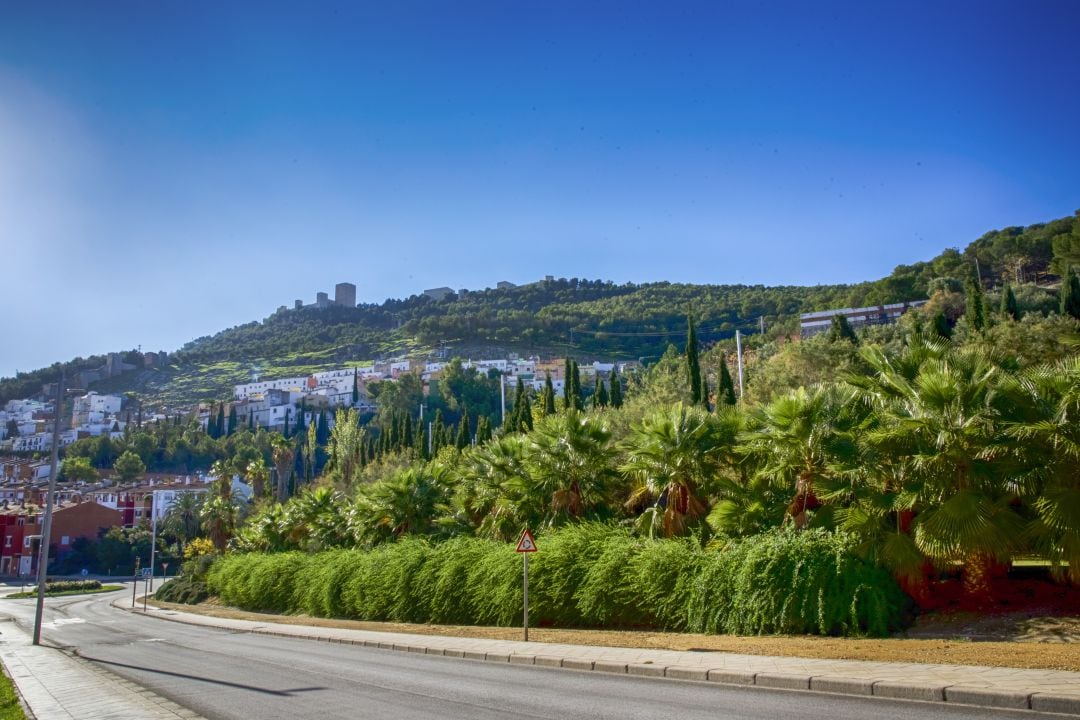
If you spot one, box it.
[0,0,1080,376]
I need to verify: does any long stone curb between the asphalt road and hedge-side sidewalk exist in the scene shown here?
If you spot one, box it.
[118,600,1080,716]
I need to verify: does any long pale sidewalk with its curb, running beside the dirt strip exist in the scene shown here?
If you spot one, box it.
[132,600,1080,716]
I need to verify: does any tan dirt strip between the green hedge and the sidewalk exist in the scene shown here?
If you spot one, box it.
[153,602,1080,673]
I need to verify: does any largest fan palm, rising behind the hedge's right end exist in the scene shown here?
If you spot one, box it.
[852,343,1023,596]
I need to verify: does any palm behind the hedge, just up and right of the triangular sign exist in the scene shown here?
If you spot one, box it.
[523,410,617,526]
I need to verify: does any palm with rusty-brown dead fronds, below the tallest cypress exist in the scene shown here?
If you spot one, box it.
[622,403,717,538]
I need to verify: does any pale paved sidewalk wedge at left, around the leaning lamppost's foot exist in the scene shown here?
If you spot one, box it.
[0,621,200,720]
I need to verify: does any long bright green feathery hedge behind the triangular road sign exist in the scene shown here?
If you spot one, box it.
[207,524,907,636]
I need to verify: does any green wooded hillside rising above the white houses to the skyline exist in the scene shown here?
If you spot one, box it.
[0,213,1080,407]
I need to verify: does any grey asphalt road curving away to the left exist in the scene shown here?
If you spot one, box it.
[0,588,1049,720]
